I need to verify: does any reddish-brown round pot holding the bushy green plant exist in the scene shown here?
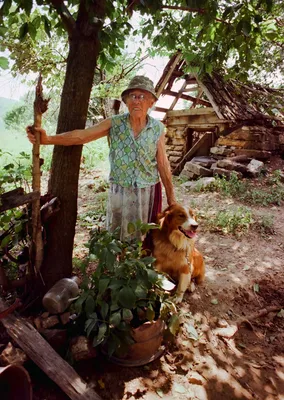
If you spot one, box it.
[106,319,165,367]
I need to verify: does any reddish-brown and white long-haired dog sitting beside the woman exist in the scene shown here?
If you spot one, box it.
[152,204,205,303]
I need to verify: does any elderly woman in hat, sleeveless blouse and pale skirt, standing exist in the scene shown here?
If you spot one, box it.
[27,76,175,240]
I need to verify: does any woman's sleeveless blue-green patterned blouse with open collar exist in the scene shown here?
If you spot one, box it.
[109,113,164,188]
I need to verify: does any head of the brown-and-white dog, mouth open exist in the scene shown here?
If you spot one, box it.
[159,204,198,239]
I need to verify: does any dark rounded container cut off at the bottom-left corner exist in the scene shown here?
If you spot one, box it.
[0,365,32,400]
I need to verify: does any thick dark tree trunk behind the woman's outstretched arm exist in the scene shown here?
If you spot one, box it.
[42,24,103,290]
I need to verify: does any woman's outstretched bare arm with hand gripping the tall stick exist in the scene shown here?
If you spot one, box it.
[26,118,111,146]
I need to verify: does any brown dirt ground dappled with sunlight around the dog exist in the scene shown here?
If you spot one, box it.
[1,161,284,400]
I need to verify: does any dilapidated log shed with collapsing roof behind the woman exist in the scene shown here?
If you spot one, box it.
[155,53,284,174]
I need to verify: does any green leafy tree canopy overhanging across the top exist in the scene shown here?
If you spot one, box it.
[0,0,284,83]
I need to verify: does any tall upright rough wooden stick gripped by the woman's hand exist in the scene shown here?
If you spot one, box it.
[32,75,49,275]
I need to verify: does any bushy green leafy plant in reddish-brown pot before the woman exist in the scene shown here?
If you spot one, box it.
[75,222,179,365]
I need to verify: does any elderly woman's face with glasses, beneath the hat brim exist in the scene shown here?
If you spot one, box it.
[125,89,155,118]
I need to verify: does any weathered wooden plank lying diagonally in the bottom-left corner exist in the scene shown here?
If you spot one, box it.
[0,298,102,400]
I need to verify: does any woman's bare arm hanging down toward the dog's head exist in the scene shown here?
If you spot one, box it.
[157,133,176,206]
